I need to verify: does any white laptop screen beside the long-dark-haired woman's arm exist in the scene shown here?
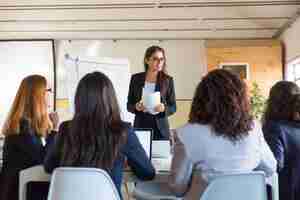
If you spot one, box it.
[134,129,152,160]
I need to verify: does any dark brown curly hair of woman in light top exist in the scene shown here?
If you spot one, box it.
[189,69,253,141]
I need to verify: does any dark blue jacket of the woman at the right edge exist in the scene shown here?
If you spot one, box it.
[263,121,300,200]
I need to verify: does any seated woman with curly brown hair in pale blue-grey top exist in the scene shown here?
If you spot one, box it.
[169,69,276,199]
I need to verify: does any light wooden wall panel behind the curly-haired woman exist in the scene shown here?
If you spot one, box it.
[206,40,283,96]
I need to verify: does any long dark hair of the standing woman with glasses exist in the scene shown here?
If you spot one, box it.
[144,46,168,93]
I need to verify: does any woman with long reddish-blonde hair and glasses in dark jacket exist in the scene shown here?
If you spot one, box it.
[0,75,58,200]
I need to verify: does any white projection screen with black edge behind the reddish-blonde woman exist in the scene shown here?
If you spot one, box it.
[0,40,54,133]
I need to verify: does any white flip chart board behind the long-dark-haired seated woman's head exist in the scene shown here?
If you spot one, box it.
[65,57,134,123]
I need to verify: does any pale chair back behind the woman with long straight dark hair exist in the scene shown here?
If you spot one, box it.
[48,167,120,200]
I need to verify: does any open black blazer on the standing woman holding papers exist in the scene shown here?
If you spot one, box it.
[127,72,176,138]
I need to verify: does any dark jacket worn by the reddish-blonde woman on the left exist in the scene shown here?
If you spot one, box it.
[0,123,54,200]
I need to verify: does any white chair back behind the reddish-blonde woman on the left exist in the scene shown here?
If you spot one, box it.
[19,165,50,200]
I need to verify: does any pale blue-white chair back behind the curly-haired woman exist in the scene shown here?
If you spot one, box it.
[200,172,267,200]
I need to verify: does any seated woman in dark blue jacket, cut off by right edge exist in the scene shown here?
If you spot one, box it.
[263,81,300,200]
